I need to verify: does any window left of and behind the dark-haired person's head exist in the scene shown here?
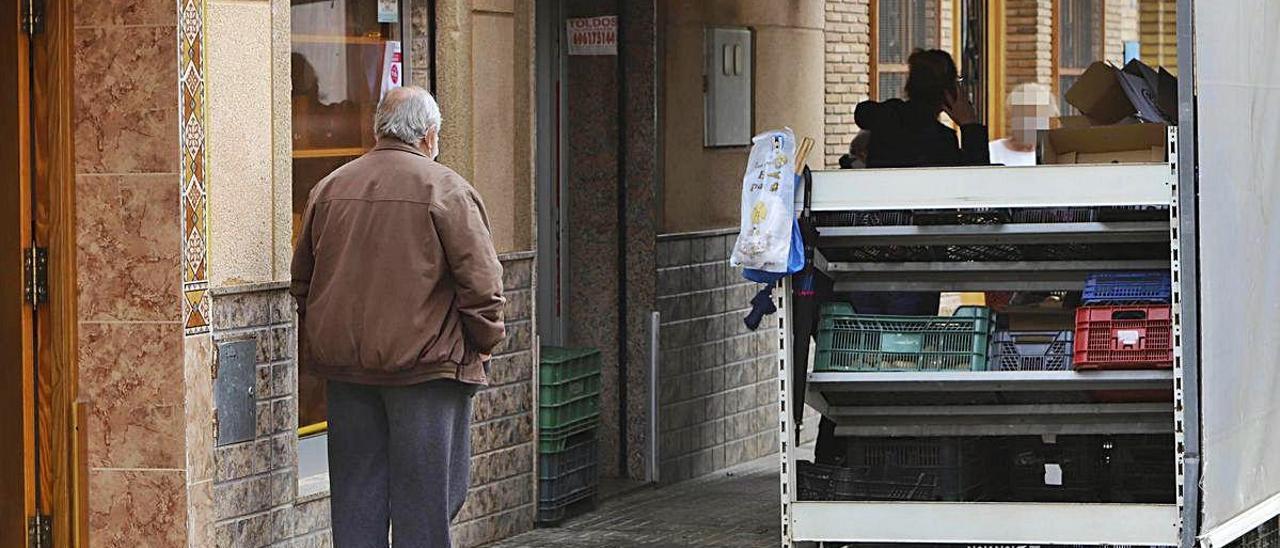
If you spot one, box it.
[874,0,941,101]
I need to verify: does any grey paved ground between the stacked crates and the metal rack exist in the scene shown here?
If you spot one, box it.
[490,455,781,548]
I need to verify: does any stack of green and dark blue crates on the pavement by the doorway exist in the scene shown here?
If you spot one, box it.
[538,346,600,525]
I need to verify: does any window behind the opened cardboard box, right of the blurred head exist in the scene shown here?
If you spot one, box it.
[1057,0,1102,115]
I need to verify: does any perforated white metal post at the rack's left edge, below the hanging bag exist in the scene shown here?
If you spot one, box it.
[776,277,795,548]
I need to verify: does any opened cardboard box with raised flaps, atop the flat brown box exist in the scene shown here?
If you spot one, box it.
[1066,59,1178,125]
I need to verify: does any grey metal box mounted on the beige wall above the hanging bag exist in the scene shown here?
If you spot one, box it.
[703,27,754,147]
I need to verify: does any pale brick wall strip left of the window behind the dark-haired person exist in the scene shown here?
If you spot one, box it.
[810,0,872,168]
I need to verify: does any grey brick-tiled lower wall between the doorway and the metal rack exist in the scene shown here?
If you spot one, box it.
[658,230,778,483]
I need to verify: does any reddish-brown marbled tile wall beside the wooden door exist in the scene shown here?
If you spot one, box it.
[73,0,188,547]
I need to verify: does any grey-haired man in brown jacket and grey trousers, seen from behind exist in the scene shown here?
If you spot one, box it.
[292,87,504,548]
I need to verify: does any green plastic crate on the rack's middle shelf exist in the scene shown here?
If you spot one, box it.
[814,303,995,371]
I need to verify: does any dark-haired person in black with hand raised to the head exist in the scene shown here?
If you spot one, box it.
[854,50,991,168]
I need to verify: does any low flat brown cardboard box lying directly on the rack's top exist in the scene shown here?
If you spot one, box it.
[1039,124,1169,164]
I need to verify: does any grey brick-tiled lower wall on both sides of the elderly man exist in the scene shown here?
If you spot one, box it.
[204,254,536,548]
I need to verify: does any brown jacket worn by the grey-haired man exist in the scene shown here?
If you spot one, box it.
[291,138,506,385]
